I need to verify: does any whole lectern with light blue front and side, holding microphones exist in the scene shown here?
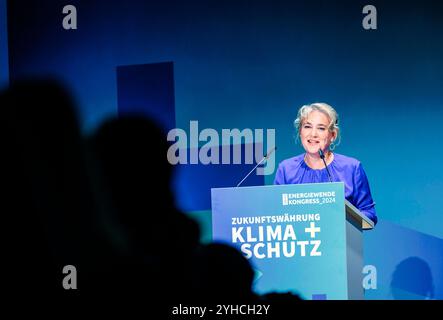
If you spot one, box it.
[211,182,374,300]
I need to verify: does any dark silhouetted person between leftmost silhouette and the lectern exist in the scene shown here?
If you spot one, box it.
[89,115,200,301]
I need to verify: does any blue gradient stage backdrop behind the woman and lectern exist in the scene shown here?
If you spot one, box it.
[4,0,443,299]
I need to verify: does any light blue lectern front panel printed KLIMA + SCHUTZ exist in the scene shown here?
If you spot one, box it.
[212,183,348,299]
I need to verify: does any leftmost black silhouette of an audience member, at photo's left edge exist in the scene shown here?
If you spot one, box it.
[0,79,111,297]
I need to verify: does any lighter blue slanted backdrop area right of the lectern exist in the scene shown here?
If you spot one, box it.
[364,220,443,300]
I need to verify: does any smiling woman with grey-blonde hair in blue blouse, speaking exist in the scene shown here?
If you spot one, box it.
[274,103,377,224]
